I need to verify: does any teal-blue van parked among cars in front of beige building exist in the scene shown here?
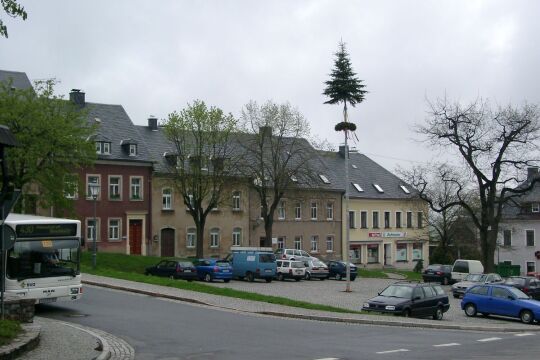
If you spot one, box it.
[225,247,276,282]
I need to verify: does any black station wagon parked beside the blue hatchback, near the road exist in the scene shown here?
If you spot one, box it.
[362,281,450,320]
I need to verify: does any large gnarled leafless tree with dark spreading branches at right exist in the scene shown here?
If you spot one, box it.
[411,99,540,271]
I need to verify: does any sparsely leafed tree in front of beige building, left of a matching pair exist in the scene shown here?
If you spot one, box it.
[164,100,237,258]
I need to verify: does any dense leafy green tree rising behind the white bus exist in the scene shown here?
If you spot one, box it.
[0,80,96,212]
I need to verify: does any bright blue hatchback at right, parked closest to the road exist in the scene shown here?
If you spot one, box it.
[461,284,540,324]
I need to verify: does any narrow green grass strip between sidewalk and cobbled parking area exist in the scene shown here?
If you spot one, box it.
[81,265,362,314]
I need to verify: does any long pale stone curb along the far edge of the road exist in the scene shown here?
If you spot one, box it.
[82,280,540,333]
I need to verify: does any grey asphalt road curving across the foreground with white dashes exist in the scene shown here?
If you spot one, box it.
[38,286,540,360]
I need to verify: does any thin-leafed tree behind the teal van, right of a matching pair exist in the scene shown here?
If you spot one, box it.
[241,101,318,246]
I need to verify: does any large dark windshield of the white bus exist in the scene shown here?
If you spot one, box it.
[7,239,80,281]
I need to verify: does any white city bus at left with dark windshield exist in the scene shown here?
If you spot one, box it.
[2,214,82,304]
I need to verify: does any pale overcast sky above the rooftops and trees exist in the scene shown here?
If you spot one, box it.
[0,0,540,170]
